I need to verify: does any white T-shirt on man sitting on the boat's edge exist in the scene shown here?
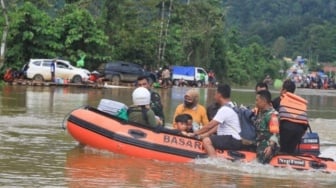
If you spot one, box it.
[213,102,241,140]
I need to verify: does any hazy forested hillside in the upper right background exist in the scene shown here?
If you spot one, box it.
[224,0,336,62]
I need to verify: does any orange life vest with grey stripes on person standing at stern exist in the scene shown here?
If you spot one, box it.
[279,92,308,125]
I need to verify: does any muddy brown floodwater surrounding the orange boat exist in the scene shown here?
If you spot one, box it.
[0,86,336,188]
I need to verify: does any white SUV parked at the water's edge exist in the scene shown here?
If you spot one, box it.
[27,59,90,83]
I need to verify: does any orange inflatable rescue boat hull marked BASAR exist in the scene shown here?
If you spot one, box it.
[66,106,336,172]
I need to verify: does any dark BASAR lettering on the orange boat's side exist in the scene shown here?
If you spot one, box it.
[163,135,202,150]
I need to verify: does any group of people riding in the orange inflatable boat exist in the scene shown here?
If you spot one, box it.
[128,77,307,163]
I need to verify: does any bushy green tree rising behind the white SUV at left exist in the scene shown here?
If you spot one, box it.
[6,2,61,68]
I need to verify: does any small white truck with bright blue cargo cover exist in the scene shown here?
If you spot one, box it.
[172,66,208,87]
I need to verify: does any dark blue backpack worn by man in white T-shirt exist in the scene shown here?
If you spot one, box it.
[230,105,257,145]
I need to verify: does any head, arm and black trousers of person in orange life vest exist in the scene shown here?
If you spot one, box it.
[272,80,308,153]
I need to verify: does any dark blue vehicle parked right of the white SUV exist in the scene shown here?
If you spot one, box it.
[104,61,156,83]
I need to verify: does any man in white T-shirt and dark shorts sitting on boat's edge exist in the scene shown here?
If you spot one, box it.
[189,84,242,157]
